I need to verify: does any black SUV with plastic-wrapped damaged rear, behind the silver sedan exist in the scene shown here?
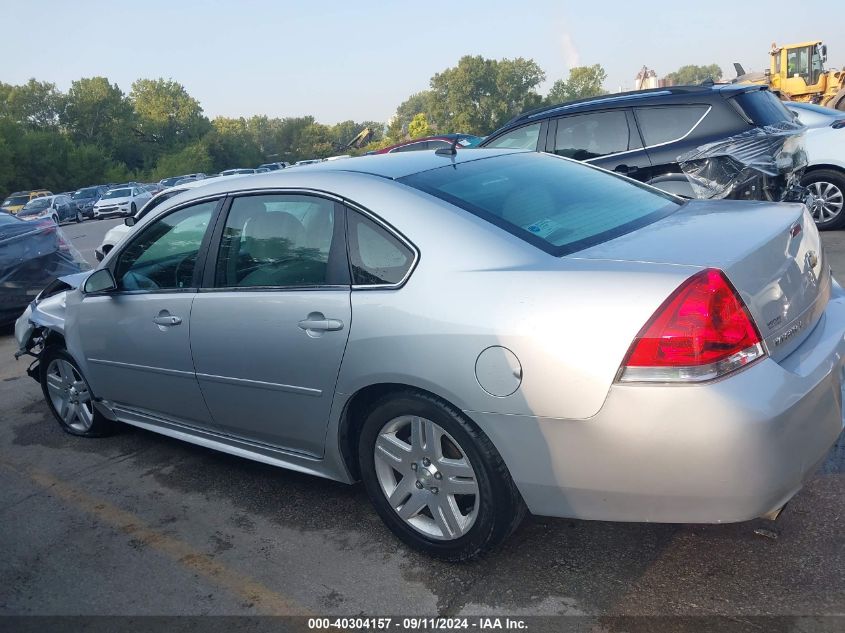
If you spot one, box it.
[480,84,806,200]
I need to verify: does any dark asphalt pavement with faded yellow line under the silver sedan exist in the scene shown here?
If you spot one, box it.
[0,220,845,630]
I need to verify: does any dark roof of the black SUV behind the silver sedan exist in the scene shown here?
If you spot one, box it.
[502,84,768,127]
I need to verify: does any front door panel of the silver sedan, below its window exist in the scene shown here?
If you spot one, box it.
[79,292,209,426]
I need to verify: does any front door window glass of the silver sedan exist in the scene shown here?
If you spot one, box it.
[114,201,217,290]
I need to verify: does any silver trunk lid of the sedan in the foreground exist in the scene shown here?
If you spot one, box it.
[570,201,831,360]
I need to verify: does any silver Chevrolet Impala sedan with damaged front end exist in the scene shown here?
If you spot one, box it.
[16,150,845,560]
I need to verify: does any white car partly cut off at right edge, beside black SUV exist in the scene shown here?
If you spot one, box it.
[784,103,845,230]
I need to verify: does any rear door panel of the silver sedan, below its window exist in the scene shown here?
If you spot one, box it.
[191,288,351,456]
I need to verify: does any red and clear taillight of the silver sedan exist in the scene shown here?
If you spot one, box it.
[619,268,765,382]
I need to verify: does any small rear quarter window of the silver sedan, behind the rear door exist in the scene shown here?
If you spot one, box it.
[347,211,414,286]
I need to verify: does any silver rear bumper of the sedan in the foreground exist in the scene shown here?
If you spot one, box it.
[467,278,845,523]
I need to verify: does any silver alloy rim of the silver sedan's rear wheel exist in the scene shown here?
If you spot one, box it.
[373,415,479,541]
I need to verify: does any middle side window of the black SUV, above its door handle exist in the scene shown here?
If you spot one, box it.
[554,110,632,160]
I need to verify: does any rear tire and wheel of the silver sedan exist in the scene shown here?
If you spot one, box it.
[358,390,526,561]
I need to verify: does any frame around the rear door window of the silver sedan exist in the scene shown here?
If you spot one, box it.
[197,188,352,293]
